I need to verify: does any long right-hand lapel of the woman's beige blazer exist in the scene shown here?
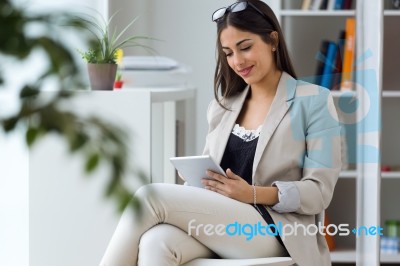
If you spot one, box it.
[253,72,297,178]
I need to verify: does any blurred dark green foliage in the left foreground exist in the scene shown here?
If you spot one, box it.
[0,0,145,211]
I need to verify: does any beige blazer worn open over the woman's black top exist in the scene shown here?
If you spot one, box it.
[203,72,341,266]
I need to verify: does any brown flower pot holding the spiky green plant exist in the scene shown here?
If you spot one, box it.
[88,64,118,91]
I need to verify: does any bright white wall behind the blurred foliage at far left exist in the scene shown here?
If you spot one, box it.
[0,0,107,266]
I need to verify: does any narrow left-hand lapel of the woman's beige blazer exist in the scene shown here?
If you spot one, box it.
[212,86,249,163]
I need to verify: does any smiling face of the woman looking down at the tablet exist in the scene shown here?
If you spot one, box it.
[220,26,276,85]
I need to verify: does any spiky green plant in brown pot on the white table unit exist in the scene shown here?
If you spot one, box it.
[78,14,153,90]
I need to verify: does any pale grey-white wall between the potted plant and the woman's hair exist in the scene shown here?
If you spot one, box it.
[109,0,233,154]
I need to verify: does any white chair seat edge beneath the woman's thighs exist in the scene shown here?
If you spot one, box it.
[182,257,294,266]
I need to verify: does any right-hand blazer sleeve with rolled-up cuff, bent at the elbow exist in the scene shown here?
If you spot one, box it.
[294,88,341,215]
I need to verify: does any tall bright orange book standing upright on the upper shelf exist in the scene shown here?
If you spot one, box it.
[341,18,356,90]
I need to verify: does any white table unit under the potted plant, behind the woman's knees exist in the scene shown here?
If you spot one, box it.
[29,88,196,266]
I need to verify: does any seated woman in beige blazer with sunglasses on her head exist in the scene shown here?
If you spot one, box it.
[101,0,341,266]
